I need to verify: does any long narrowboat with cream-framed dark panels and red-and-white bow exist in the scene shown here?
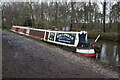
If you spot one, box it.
[11,26,100,57]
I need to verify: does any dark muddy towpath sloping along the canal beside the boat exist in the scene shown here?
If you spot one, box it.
[2,32,118,78]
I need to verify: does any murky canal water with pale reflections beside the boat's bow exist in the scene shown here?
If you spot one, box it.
[90,39,120,67]
